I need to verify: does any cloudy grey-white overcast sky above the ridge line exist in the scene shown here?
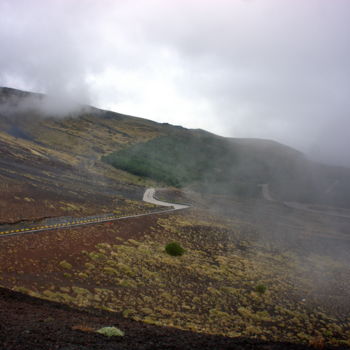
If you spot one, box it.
[0,0,350,166]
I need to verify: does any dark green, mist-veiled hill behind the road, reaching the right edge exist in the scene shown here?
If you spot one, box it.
[102,130,350,207]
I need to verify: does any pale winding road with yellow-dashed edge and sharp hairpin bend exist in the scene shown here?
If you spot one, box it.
[0,188,190,238]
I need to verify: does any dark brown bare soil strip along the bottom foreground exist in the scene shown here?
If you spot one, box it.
[0,288,346,350]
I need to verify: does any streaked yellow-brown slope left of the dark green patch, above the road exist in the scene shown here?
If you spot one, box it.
[0,88,167,222]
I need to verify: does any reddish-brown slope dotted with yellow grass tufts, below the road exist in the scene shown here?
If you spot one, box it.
[0,208,350,345]
